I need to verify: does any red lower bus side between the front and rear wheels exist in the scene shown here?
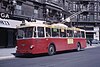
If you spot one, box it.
[49,38,78,51]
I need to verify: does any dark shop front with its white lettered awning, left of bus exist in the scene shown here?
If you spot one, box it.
[0,19,21,48]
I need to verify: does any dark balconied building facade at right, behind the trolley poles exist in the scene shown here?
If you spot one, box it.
[68,0,100,40]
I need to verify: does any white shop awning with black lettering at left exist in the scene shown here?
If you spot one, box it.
[0,18,22,28]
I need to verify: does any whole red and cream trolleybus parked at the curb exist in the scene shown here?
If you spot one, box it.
[16,22,86,55]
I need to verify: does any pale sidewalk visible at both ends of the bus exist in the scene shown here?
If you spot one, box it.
[0,44,100,60]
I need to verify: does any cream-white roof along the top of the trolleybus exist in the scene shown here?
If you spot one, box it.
[17,22,85,31]
